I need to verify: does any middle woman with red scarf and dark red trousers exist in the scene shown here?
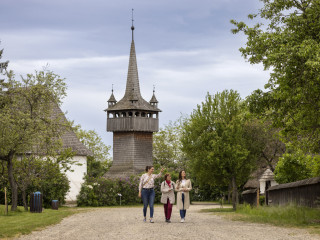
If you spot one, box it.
[161,173,175,223]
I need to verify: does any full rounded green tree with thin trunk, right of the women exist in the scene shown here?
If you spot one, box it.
[182,90,256,209]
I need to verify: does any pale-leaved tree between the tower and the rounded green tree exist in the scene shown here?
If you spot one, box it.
[153,116,188,171]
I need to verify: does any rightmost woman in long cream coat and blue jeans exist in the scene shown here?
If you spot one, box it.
[176,170,192,223]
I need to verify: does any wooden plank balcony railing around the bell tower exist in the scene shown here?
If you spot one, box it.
[107,117,159,132]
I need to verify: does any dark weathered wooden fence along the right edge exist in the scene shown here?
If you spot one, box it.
[267,177,320,208]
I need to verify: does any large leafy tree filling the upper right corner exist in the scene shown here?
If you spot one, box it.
[231,0,320,153]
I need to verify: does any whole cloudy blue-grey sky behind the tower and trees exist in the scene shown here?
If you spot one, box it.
[0,0,268,149]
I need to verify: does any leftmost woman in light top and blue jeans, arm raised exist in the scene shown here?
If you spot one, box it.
[139,166,163,223]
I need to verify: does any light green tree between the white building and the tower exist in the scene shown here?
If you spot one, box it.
[75,125,112,177]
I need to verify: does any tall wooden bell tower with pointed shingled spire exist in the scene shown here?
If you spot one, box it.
[105,17,161,177]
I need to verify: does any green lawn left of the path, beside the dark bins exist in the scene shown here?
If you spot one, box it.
[0,205,89,238]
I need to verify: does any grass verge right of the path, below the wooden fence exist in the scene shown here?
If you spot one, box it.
[202,205,320,234]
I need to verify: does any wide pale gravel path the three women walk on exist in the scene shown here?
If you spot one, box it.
[18,205,320,240]
